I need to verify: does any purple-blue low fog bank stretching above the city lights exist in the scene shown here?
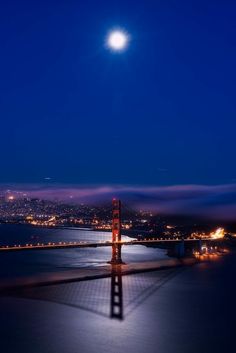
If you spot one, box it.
[0,184,236,220]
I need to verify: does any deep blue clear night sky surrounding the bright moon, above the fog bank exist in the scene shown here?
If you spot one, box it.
[0,0,236,185]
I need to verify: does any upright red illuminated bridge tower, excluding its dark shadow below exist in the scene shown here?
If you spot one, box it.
[111,199,122,265]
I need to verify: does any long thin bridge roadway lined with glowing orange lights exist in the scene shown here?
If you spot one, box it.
[0,238,212,252]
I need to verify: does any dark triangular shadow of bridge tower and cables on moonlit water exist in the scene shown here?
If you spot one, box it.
[1,265,183,320]
